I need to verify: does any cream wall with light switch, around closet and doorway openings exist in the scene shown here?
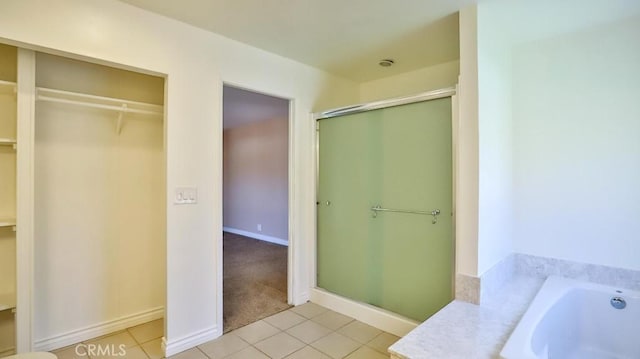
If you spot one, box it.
[0,0,358,354]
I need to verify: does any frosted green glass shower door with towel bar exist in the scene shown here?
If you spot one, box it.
[317,98,454,321]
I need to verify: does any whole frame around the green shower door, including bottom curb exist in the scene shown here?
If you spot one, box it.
[309,86,459,336]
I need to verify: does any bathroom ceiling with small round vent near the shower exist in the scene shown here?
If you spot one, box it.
[121,0,475,82]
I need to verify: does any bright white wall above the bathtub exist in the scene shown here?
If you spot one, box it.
[468,0,640,275]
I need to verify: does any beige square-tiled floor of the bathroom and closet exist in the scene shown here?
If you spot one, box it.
[54,303,399,359]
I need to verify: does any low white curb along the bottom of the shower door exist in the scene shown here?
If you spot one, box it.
[311,288,419,337]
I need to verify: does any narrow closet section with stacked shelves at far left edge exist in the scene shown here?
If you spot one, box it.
[0,44,17,357]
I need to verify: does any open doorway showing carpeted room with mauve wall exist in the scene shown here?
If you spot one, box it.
[223,85,289,332]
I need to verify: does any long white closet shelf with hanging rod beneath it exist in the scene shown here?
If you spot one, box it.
[37,87,164,116]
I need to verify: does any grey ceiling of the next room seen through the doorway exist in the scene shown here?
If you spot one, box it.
[222,86,289,130]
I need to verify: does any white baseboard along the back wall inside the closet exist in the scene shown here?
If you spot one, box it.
[34,307,164,351]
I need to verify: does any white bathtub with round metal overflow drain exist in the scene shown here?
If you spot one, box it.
[500,276,640,359]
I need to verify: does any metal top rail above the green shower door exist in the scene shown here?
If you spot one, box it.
[314,87,456,120]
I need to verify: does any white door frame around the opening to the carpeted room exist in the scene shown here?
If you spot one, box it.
[216,79,301,334]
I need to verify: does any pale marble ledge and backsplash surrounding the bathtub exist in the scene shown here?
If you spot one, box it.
[389,253,640,359]
